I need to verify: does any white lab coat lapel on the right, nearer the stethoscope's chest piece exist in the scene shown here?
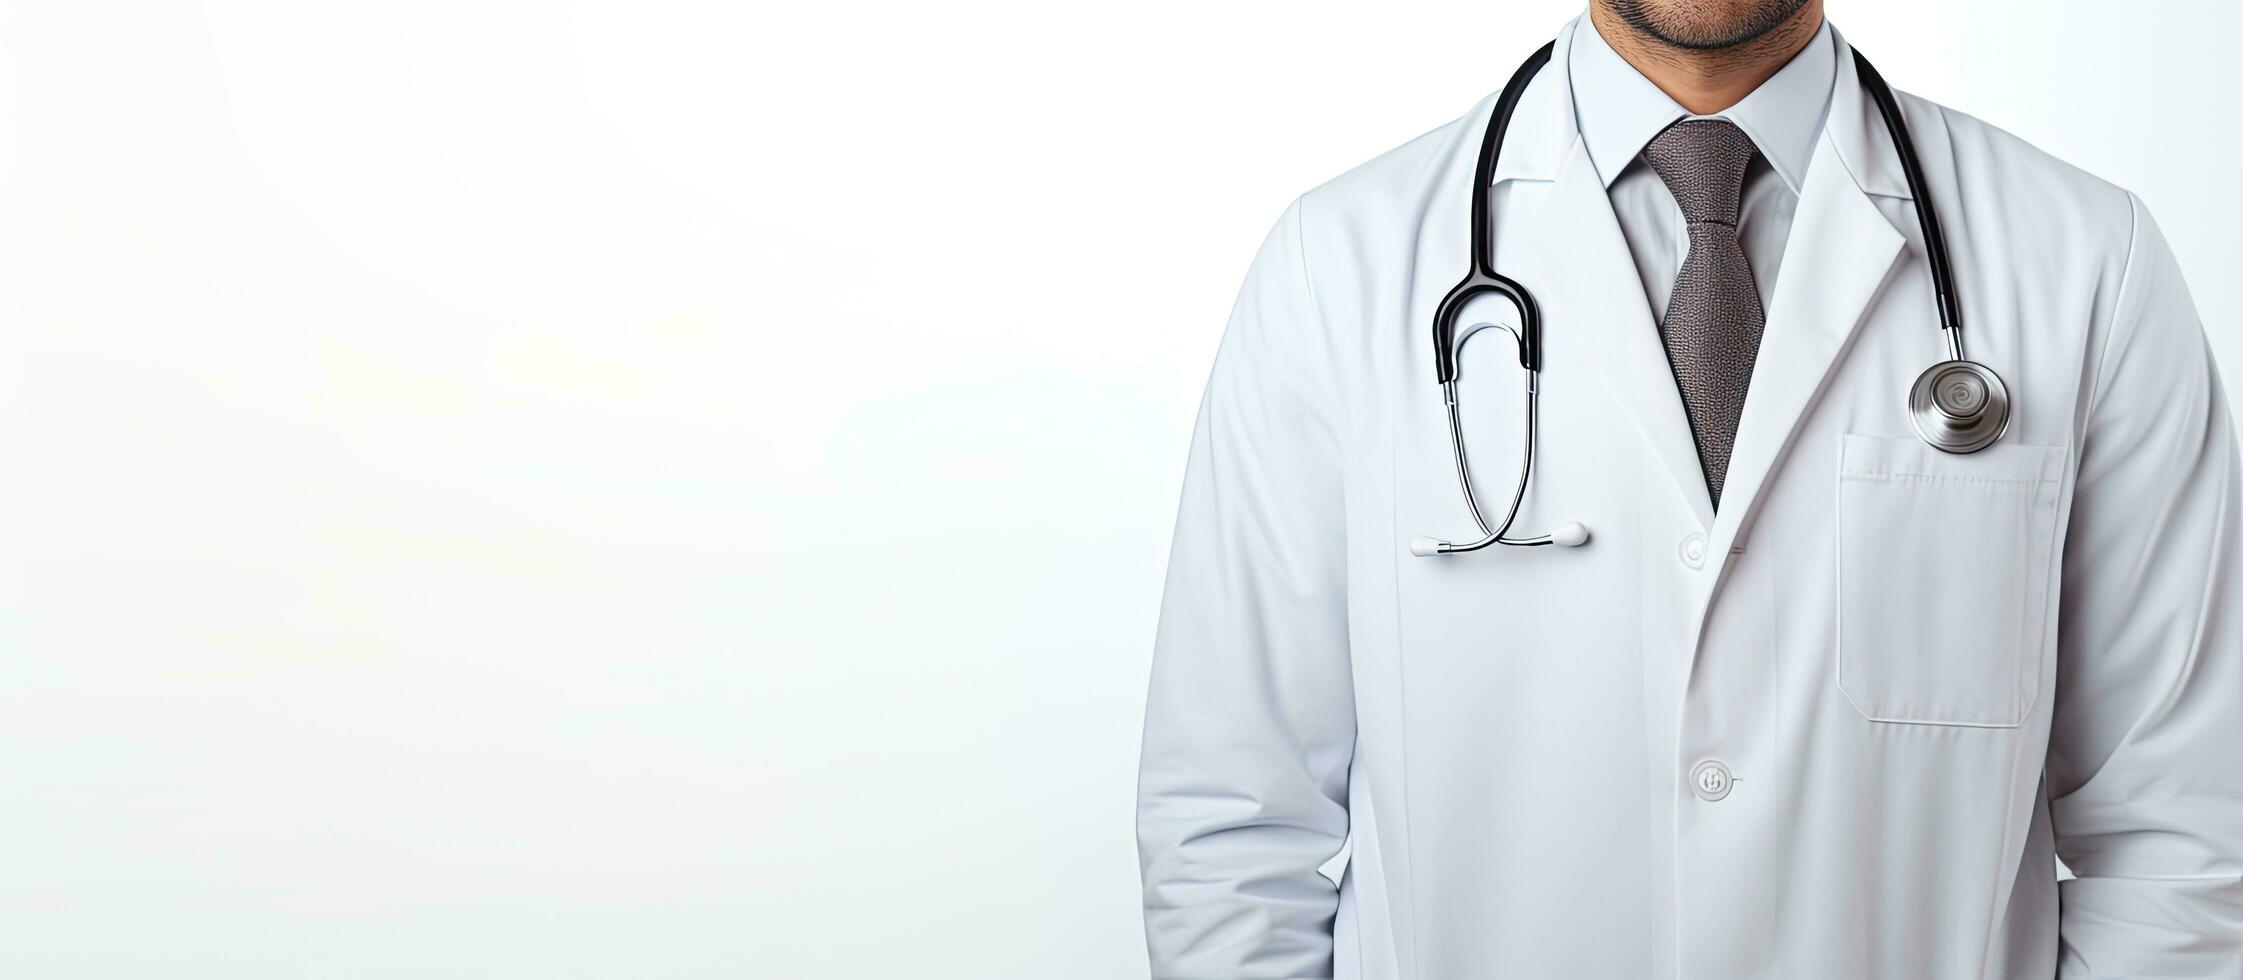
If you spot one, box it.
[1707,54,1907,578]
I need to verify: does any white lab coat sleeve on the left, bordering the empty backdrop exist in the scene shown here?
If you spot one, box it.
[1137,202,1355,980]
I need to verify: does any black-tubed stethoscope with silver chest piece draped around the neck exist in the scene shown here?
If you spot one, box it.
[1409,43,2010,556]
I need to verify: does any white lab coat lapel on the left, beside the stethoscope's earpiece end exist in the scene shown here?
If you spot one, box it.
[1519,139,1714,527]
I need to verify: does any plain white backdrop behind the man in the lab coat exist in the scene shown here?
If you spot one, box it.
[0,0,2243,980]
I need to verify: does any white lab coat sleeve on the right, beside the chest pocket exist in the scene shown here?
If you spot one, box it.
[2046,195,2243,978]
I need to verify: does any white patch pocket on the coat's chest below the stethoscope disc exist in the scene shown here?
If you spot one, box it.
[1837,433,2064,729]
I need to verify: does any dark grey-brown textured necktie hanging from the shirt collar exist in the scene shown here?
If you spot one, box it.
[1644,119,1767,507]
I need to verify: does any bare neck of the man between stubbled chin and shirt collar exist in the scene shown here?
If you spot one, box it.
[1588,0,1821,117]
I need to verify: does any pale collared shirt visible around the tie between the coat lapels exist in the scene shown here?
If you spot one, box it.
[1566,16,1837,321]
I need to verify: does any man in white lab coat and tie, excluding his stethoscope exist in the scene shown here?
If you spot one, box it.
[1137,0,2243,980]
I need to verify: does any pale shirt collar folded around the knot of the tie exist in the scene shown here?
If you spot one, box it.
[1566,13,1837,193]
